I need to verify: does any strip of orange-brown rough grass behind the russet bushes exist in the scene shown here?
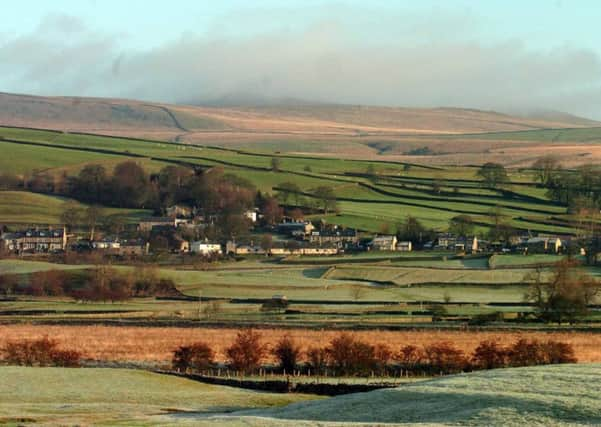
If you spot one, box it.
[0,325,601,363]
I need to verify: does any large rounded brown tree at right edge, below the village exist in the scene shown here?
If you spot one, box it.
[524,259,601,324]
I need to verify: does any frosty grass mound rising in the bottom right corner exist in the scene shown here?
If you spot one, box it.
[236,365,601,426]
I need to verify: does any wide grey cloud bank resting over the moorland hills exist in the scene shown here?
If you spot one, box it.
[0,11,601,119]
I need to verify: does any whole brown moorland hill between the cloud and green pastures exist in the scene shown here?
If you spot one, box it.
[0,93,601,167]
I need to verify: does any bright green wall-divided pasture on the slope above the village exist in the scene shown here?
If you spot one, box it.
[0,127,581,233]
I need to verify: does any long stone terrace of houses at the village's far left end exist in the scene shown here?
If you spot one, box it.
[1,228,67,253]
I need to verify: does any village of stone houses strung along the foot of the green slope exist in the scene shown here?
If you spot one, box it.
[0,201,585,260]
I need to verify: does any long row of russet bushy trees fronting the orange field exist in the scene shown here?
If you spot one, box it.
[172,329,576,376]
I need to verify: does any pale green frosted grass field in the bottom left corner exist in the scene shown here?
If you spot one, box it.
[0,367,309,425]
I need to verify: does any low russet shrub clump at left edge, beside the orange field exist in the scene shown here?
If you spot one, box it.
[2,337,81,367]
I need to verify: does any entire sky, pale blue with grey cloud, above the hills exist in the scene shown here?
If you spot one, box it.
[0,0,601,119]
